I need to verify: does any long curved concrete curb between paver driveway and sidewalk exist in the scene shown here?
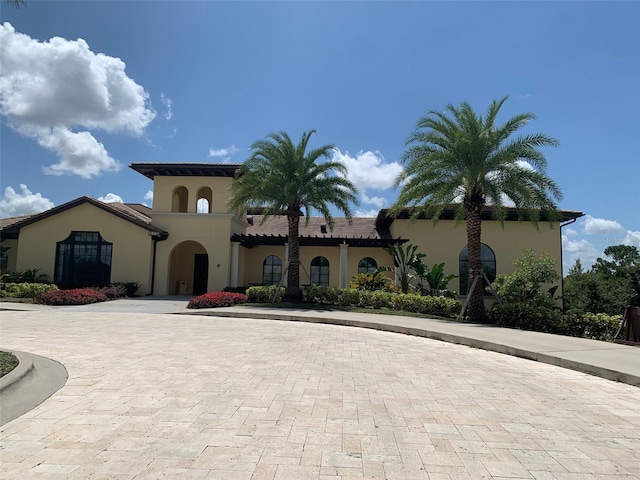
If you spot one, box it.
[188,310,640,386]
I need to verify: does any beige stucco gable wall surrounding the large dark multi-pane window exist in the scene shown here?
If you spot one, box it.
[16,204,151,295]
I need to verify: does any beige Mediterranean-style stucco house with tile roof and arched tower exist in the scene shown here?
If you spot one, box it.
[0,163,583,295]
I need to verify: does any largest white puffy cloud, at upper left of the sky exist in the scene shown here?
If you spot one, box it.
[0,23,156,178]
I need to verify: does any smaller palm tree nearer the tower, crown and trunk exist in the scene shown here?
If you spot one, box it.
[229,130,358,299]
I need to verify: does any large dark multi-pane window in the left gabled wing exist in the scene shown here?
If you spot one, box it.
[54,232,113,288]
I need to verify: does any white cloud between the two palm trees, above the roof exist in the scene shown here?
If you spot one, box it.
[332,149,402,209]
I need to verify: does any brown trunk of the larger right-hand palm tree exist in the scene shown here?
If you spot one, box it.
[464,202,488,323]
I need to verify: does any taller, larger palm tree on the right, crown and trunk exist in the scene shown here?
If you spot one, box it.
[392,97,562,321]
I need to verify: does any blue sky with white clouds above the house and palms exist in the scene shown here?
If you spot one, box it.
[0,0,640,273]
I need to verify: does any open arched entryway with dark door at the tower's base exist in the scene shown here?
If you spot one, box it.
[167,240,209,295]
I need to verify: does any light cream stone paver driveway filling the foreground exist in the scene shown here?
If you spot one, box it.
[0,310,640,480]
